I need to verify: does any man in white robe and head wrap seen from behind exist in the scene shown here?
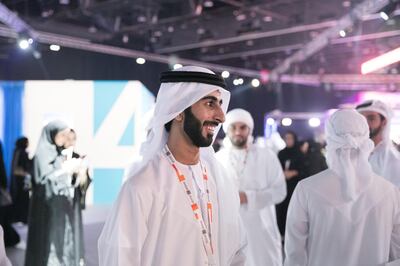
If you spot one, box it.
[285,109,400,266]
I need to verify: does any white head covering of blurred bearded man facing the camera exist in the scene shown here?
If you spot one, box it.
[222,108,254,148]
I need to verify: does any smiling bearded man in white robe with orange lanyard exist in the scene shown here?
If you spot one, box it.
[98,67,245,266]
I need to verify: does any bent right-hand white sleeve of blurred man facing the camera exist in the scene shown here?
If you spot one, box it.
[244,150,286,210]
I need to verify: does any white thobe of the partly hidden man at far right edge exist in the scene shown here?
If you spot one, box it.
[369,142,400,188]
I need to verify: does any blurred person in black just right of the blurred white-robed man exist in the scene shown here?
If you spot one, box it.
[276,131,305,239]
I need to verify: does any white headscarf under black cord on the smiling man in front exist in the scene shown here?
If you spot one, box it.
[125,66,230,176]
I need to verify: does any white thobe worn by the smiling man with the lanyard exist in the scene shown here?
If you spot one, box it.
[98,153,245,266]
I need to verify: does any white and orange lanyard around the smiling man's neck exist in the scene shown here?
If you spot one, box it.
[163,145,214,264]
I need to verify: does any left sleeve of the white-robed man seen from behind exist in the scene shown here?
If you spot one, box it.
[285,182,309,266]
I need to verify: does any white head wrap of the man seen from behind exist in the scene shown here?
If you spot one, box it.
[325,109,374,201]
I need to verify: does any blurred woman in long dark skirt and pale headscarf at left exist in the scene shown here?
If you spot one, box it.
[25,121,82,266]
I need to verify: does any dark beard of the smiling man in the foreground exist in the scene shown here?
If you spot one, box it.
[183,107,218,147]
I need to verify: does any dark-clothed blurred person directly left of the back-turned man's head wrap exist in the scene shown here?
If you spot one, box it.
[300,139,328,177]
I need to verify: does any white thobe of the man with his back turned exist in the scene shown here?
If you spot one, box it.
[285,169,400,266]
